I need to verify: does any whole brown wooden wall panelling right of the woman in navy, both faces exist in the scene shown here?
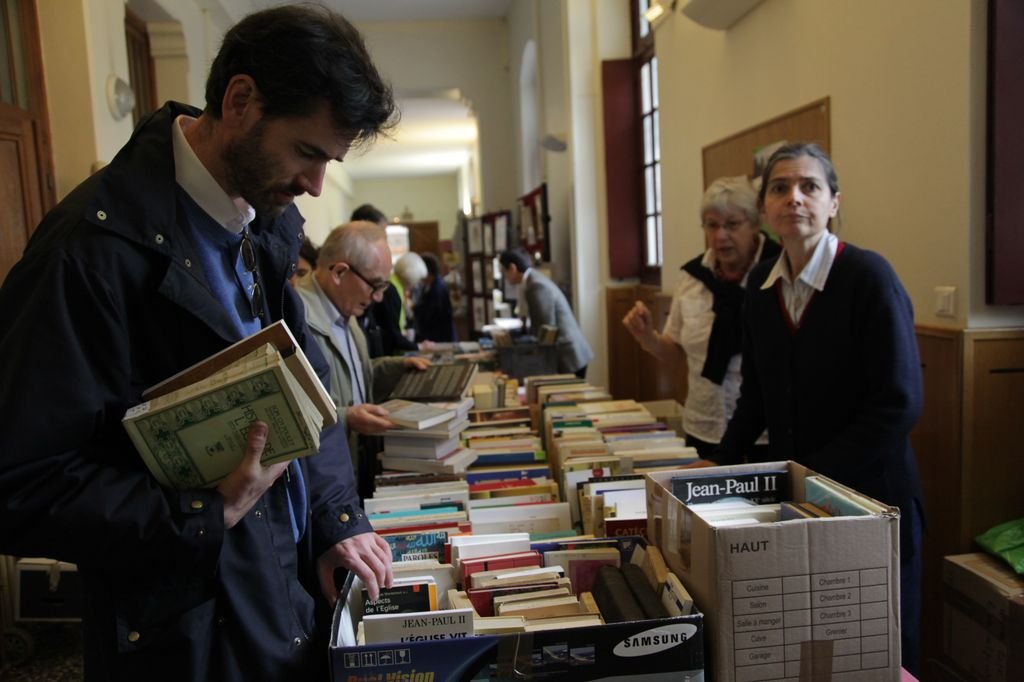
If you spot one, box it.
[910,327,1024,680]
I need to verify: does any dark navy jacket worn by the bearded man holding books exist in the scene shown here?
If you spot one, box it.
[0,103,370,682]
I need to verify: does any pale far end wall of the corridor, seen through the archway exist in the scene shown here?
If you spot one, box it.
[352,173,459,240]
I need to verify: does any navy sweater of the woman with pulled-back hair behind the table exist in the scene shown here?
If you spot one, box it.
[712,244,922,558]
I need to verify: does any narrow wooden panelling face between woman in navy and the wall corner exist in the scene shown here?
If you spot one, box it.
[910,328,967,675]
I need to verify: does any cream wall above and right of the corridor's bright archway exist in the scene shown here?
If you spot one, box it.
[358,19,518,212]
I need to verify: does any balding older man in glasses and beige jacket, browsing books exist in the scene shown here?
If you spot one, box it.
[295,220,430,497]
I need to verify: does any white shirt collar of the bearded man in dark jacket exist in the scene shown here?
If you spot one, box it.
[171,115,256,235]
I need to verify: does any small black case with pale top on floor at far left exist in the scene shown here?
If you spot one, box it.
[14,558,82,623]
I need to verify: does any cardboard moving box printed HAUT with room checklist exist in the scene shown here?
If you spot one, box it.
[647,462,900,682]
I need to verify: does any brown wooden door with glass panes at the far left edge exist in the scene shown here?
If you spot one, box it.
[0,1,54,283]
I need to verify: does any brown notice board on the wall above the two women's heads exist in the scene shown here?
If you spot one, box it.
[703,97,831,187]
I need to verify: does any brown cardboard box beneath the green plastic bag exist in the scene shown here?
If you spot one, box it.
[942,553,1024,682]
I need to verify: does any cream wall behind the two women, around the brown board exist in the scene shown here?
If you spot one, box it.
[655,0,1024,327]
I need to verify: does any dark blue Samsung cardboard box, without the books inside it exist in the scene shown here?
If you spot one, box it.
[330,561,705,682]
